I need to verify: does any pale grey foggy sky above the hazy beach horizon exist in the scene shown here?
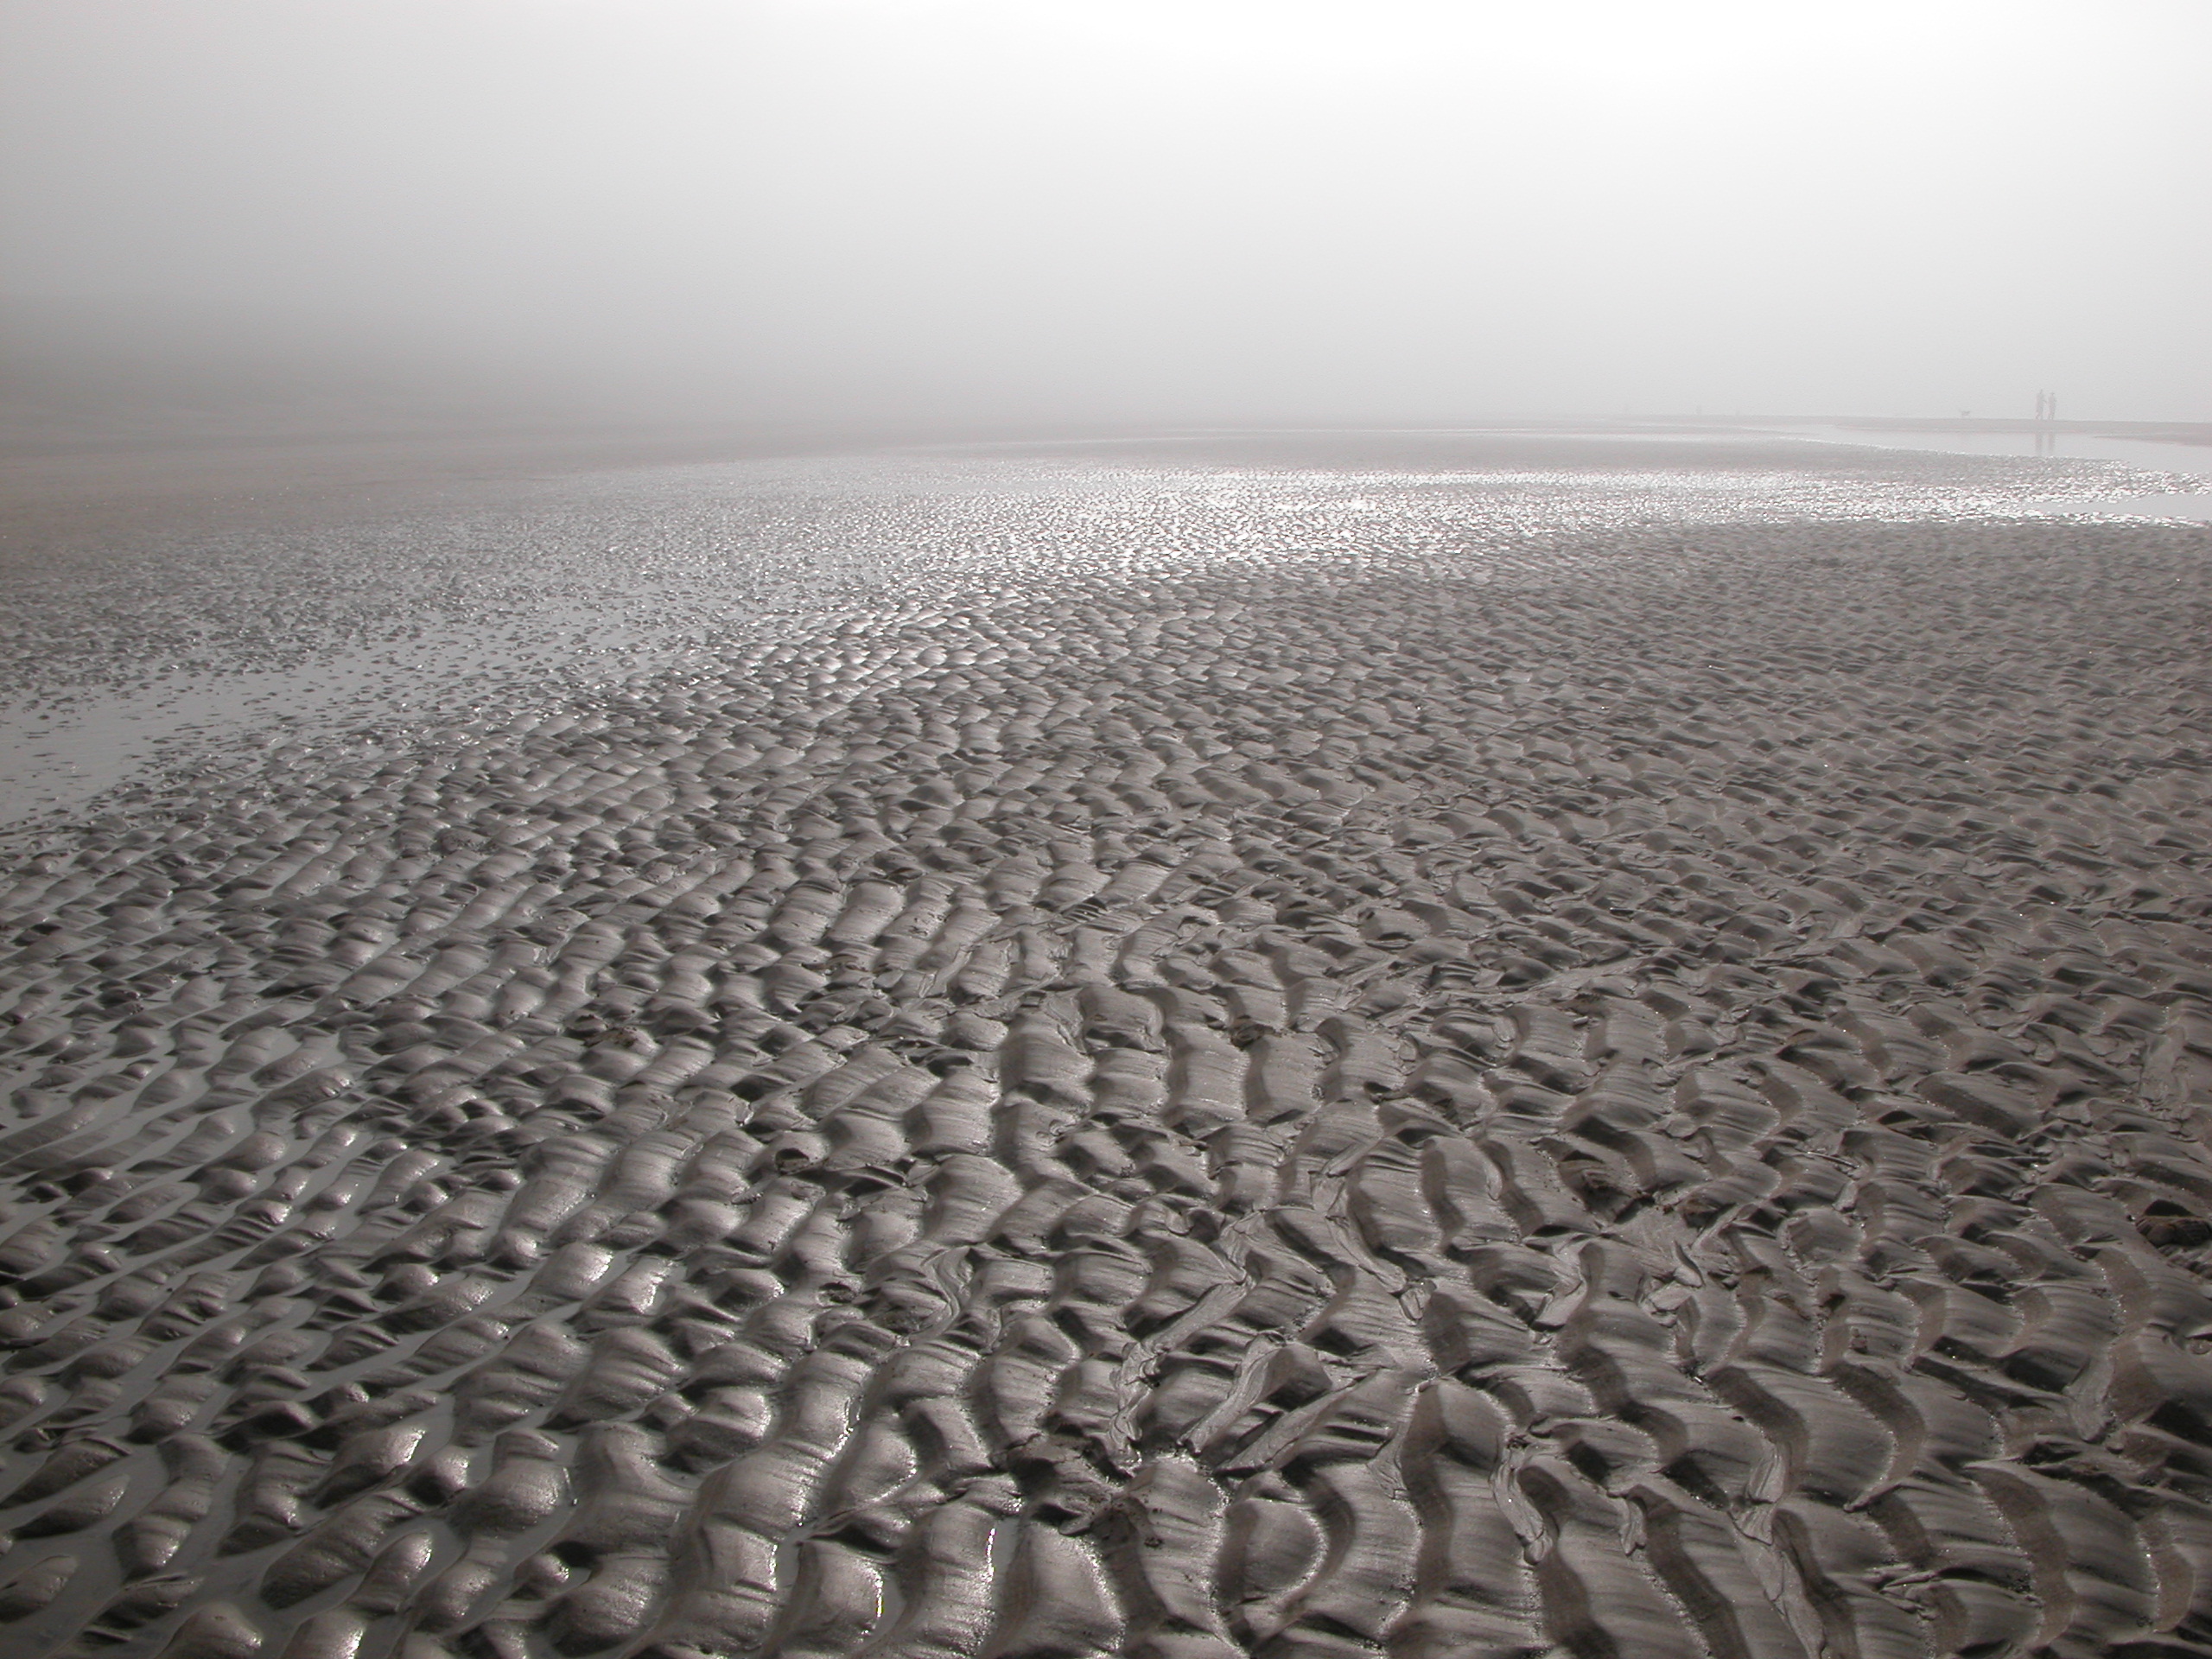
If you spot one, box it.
[0,0,2212,423]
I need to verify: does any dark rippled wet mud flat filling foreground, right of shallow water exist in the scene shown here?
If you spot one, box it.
[0,442,2212,1659]
